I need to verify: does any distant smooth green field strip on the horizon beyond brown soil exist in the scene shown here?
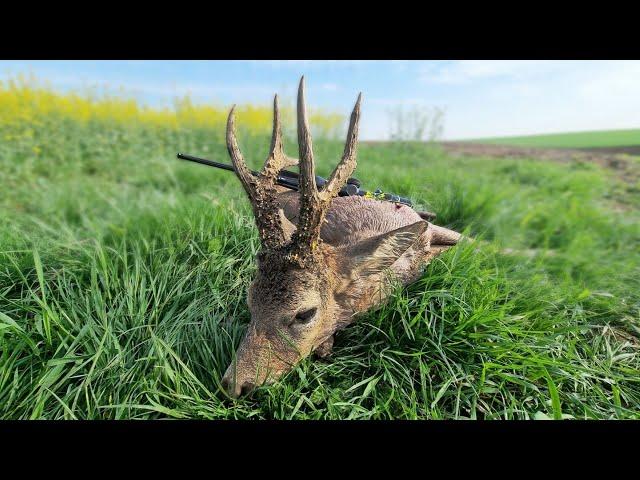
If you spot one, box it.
[469,129,640,148]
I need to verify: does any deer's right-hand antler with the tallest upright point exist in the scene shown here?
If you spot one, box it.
[291,77,362,260]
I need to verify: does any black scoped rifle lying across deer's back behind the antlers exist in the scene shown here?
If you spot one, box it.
[177,153,413,207]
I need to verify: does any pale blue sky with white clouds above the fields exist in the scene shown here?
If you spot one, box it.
[0,60,640,140]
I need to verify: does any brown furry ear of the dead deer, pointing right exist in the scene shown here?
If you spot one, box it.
[344,221,429,277]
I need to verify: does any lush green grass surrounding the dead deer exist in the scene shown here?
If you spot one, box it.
[0,84,640,419]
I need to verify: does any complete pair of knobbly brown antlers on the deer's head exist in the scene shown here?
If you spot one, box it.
[227,77,362,264]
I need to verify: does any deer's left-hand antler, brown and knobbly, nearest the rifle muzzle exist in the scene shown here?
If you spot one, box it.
[227,95,297,249]
